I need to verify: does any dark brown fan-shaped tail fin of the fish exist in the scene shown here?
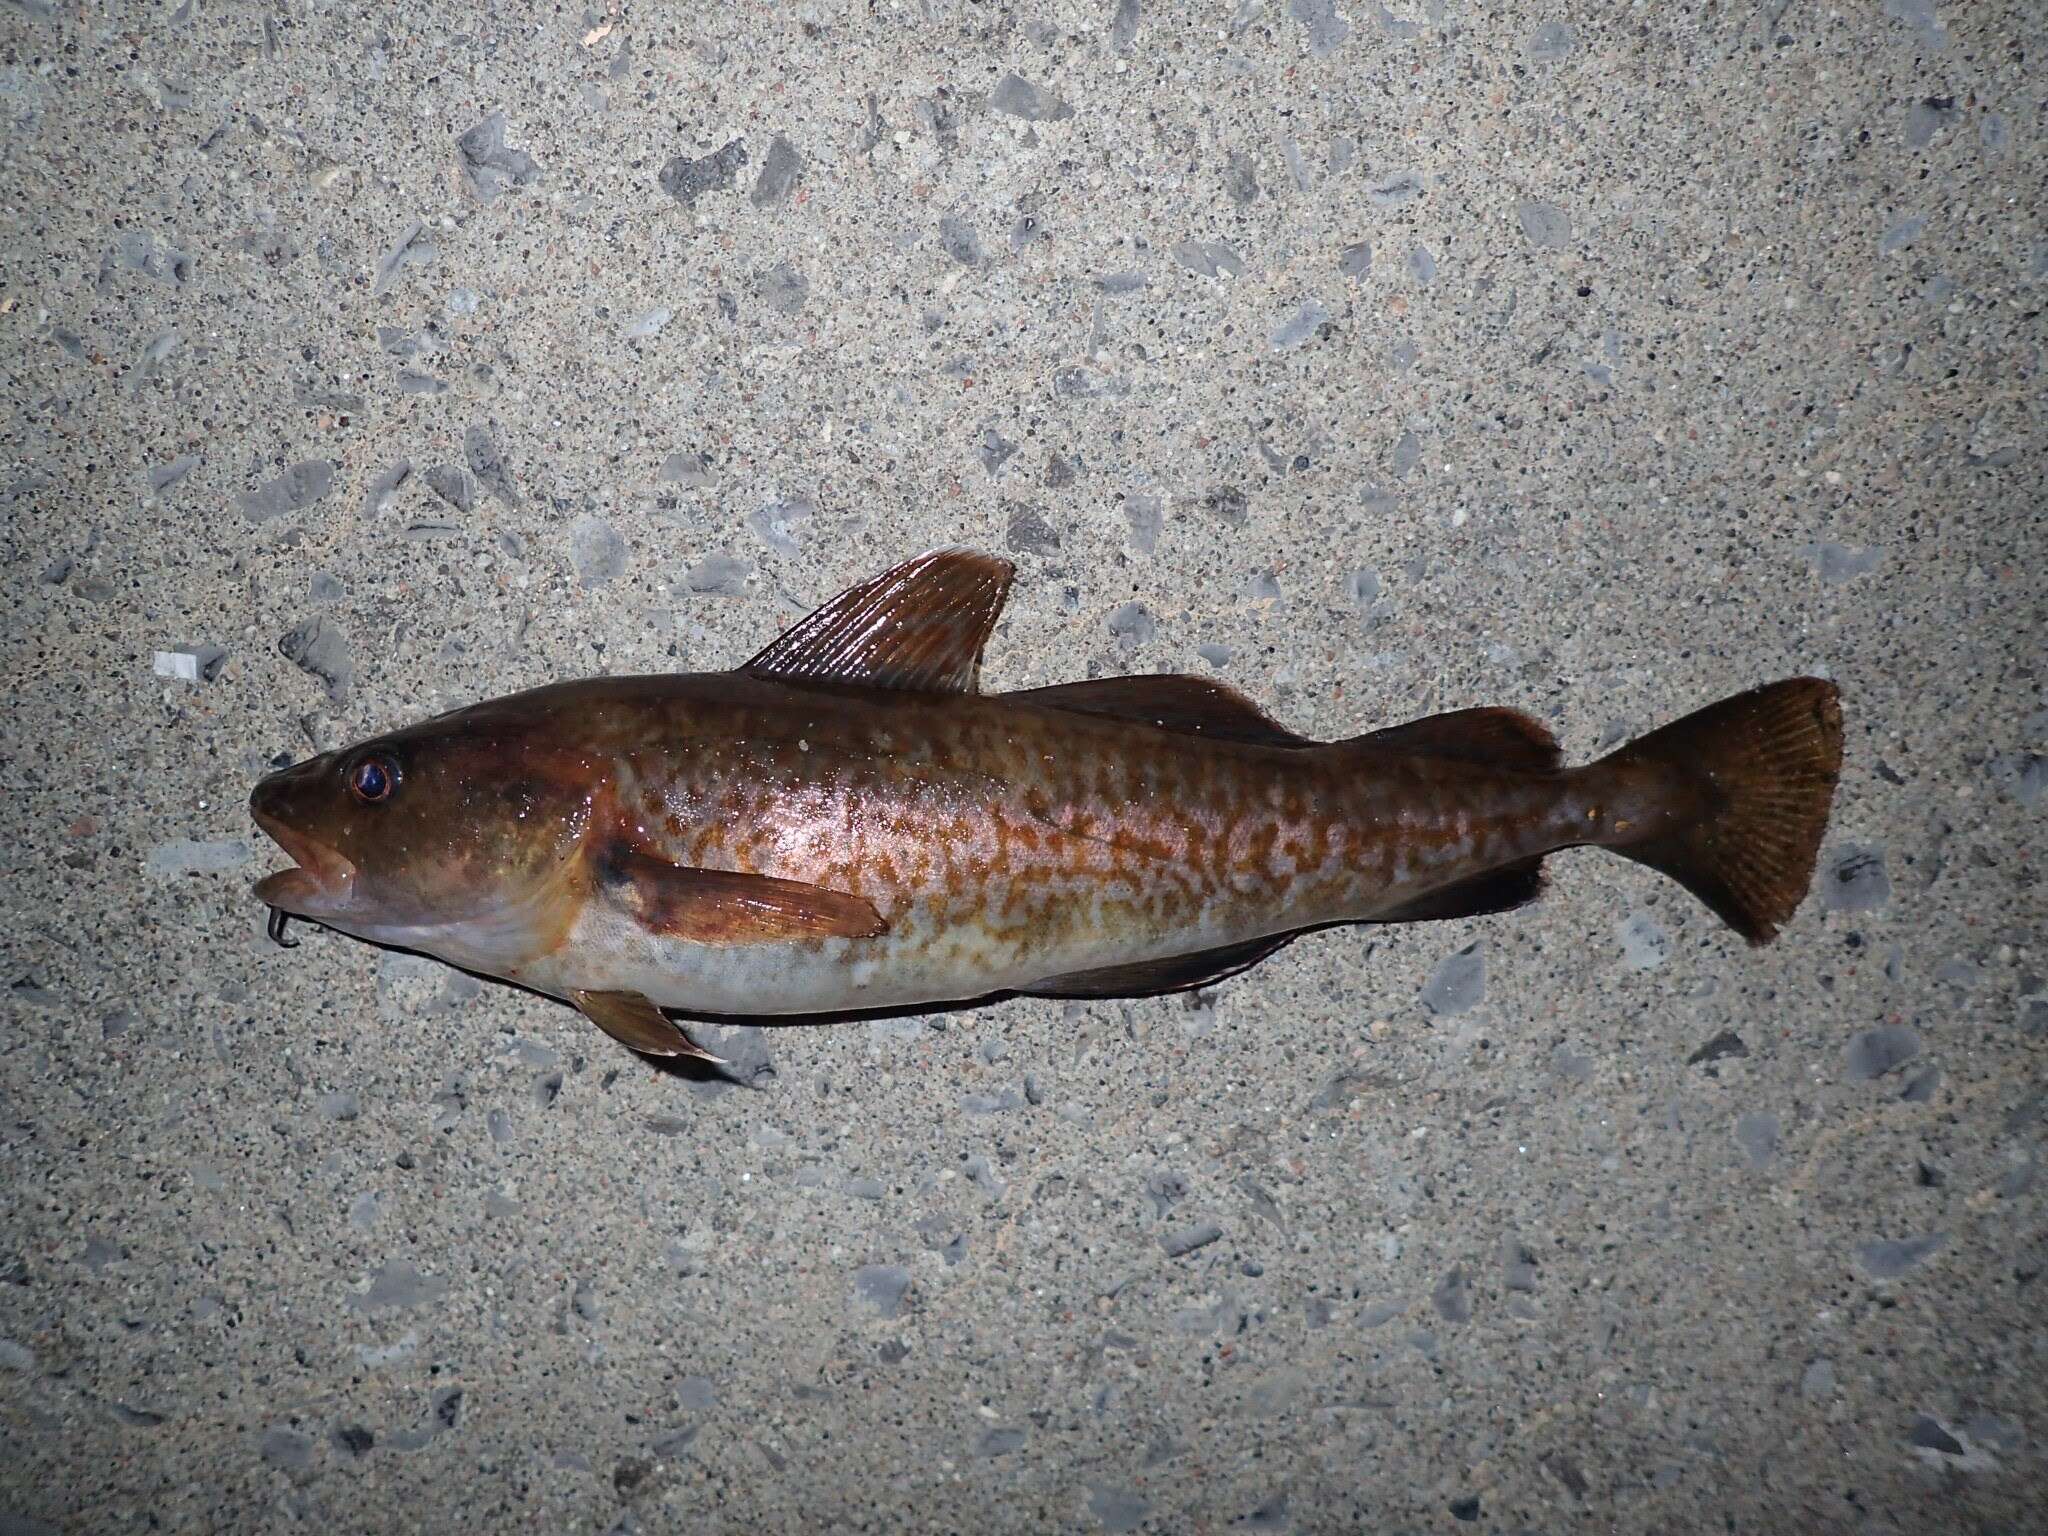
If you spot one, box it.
[1593,678,1841,944]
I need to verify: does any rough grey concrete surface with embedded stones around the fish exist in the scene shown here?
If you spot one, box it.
[0,0,2048,1532]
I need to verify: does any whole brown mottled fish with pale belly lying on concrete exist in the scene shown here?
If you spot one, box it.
[250,549,1841,1061]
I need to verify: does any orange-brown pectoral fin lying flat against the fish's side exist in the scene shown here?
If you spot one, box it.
[596,846,889,944]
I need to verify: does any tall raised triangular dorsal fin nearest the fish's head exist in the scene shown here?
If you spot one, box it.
[741,549,1012,694]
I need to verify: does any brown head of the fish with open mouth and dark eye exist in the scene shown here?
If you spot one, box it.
[250,711,604,965]
